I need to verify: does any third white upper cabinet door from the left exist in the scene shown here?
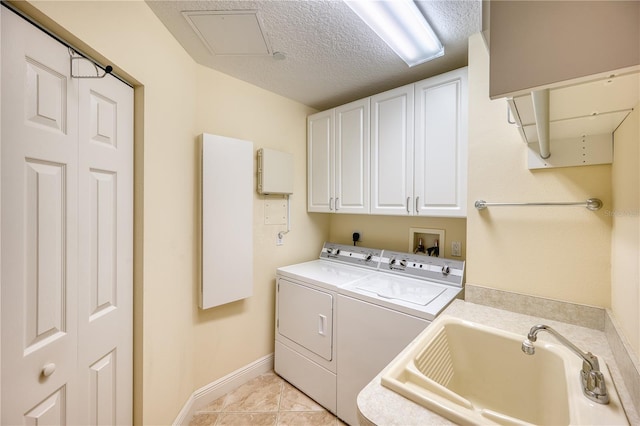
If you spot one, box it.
[371,84,414,215]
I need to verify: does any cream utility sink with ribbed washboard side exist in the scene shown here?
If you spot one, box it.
[382,315,629,425]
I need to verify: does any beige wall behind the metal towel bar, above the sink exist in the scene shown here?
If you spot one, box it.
[466,34,611,307]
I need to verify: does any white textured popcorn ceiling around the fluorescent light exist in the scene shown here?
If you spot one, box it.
[146,0,481,110]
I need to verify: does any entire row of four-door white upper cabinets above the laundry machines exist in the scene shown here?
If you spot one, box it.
[308,68,468,217]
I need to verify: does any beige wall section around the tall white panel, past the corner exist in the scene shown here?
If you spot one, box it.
[194,67,328,387]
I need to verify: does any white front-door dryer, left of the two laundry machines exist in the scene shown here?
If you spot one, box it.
[274,243,382,414]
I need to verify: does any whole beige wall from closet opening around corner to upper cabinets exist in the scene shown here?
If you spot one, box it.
[20,1,328,424]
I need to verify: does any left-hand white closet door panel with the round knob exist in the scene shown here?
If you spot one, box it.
[0,7,78,424]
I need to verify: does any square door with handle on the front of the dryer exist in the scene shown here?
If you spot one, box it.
[278,278,333,361]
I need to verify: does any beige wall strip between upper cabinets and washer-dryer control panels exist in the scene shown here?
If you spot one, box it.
[329,214,467,260]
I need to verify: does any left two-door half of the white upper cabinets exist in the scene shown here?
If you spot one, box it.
[307,98,369,213]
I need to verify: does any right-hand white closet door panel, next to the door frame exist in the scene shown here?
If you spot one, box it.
[78,76,133,424]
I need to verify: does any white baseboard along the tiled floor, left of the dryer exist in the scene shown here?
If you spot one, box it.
[173,354,273,426]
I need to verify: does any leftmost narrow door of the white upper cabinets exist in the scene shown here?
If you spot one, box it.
[307,109,334,212]
